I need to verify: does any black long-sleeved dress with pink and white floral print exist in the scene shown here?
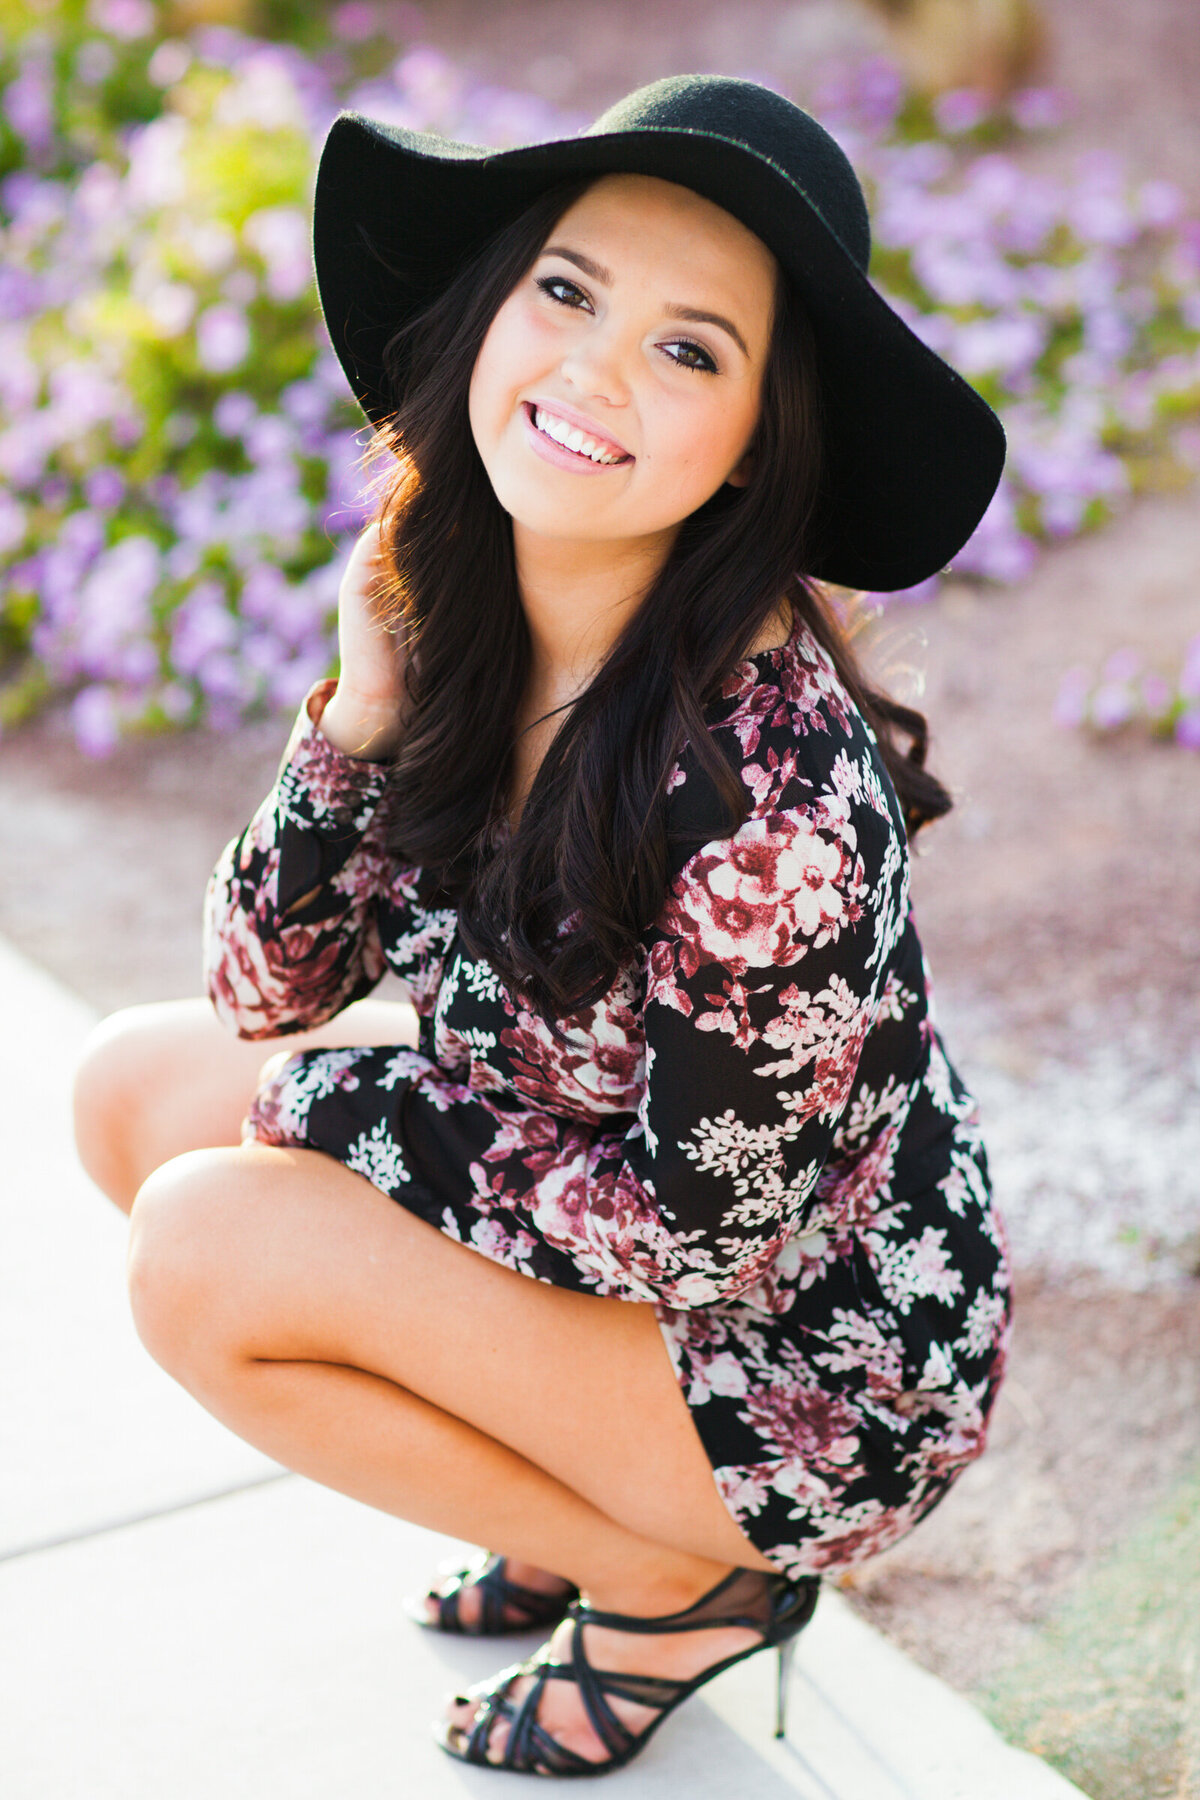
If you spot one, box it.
[207,621,1009,1575]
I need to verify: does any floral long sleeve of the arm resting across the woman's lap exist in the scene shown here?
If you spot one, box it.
[250,694,907,1309]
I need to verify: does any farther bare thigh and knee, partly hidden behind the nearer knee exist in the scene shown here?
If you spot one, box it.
[76,999,416,1210]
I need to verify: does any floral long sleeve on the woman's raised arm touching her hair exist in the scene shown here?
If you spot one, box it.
[203,682,431,1039]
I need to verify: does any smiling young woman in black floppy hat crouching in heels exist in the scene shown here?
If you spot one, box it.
[79,77,1007,1775]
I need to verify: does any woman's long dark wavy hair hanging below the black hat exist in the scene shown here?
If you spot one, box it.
[361,182,950,1026]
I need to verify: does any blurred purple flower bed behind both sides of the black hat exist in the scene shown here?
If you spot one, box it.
[0,0,1200,754]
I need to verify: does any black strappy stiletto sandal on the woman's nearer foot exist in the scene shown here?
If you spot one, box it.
[435,1570,820,1775]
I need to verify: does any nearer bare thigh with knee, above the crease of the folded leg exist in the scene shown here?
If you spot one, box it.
[133,1145,768,1568]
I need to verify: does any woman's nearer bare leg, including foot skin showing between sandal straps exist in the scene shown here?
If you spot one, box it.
[130,1145,770,1755]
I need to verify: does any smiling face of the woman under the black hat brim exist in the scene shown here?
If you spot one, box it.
[470,175,777,553]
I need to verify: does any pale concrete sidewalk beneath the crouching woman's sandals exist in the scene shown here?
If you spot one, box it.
[0,945,1079,1800]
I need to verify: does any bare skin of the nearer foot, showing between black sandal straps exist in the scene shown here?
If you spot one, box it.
[444,1569,763,1762]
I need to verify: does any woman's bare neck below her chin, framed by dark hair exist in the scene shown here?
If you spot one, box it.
[513,520,671,706]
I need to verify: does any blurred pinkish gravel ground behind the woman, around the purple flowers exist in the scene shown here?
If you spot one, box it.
[0,0,1200,1687]
